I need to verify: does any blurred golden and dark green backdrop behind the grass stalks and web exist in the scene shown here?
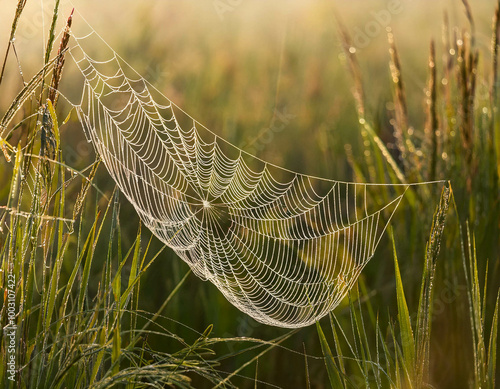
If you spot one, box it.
[0,0,499,388]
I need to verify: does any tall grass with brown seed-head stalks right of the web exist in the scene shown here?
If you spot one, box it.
[318,0,500,388]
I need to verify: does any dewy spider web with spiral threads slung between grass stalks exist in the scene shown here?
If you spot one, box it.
[69,31,409,328]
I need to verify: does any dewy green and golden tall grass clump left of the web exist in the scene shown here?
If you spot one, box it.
[0,1,292,388]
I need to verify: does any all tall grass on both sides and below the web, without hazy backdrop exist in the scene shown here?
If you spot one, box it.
[0,0,500,388]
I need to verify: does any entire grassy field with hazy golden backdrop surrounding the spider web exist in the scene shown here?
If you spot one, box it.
[0,0,500,389]
